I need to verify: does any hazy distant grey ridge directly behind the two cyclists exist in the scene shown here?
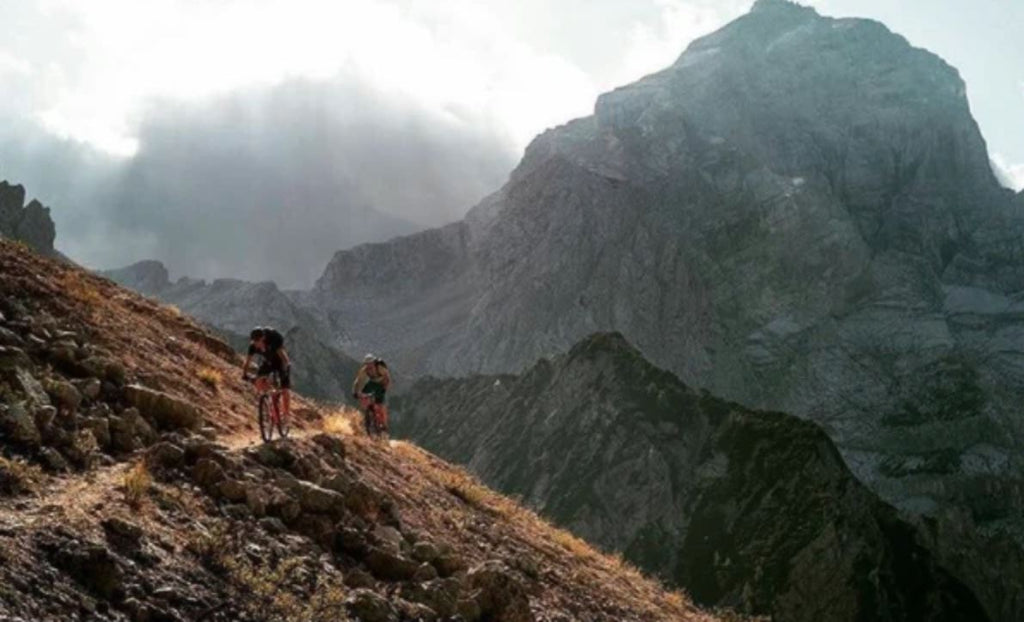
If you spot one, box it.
[102,261,358,401]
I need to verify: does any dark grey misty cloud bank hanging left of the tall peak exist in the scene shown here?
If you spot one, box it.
[0,74,518,288]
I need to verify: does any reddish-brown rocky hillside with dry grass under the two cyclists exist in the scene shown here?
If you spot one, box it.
[0,240,723,622]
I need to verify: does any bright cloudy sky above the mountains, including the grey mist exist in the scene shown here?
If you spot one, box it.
[0,0,1024,287]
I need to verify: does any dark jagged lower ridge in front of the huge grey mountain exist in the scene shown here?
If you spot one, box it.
[393,334,988,622]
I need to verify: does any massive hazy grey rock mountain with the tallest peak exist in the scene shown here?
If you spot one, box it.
[310,0,1024,541]
